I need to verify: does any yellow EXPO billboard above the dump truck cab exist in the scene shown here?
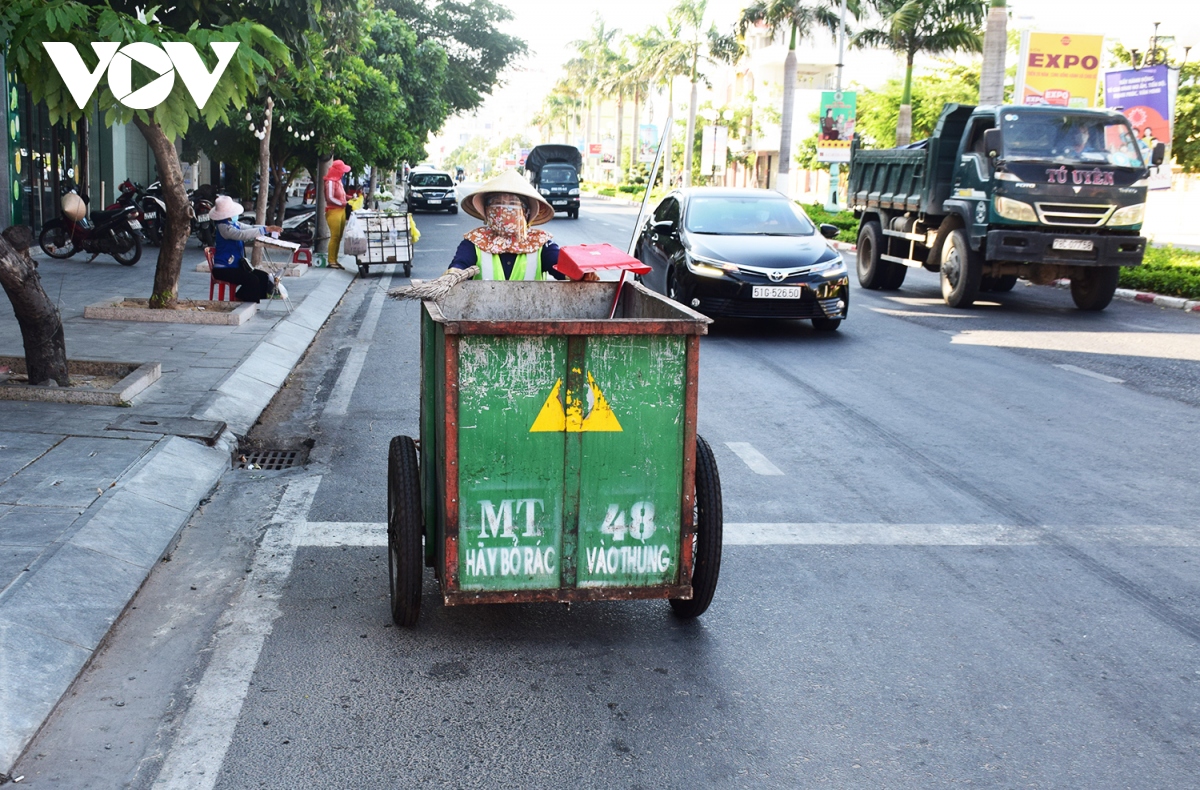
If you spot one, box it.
[1013,30,1104,107]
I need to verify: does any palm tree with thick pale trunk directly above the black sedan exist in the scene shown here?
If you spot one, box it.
[738,0,858,194]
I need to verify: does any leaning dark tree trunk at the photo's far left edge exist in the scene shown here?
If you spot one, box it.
[0,226,71,387]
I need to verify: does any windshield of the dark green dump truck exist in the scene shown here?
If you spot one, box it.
[1001,112,1150,167]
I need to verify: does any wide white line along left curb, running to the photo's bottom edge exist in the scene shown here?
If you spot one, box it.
[154,475,320,790]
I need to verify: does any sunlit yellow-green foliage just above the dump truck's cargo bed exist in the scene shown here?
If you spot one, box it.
[856,61,979,148]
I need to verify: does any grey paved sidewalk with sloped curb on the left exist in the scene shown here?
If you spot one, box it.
[0,240,354,777]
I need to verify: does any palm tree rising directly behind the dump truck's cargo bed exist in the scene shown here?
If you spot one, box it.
[853,0,984,145]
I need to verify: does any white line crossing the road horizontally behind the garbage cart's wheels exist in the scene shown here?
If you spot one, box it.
[293,521,1200,549]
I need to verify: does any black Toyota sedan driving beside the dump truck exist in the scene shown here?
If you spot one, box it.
[634,187,850,331]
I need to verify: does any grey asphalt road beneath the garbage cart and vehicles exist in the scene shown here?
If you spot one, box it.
[16,192,1200,789]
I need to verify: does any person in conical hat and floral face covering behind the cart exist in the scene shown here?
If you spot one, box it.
[450,170,595,281]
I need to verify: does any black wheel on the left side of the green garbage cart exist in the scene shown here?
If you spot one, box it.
[388,436,425,627]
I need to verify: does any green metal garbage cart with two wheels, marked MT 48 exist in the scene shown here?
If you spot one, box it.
[388,281,722,626]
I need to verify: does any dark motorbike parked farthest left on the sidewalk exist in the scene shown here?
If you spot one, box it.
[37,181,142,267]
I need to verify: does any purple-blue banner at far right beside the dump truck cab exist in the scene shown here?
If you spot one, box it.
[1104,66,1180,190]
